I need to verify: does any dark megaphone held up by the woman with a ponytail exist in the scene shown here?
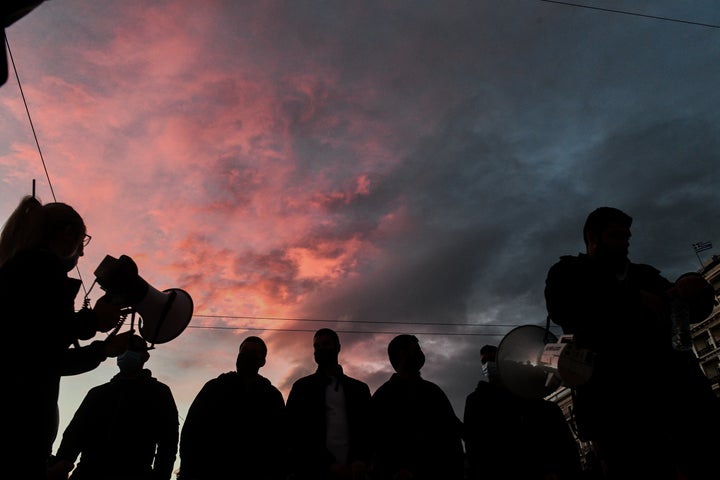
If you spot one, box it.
[95,255,193,344]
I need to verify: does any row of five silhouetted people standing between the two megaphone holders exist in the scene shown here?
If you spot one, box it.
[50,328,581,480]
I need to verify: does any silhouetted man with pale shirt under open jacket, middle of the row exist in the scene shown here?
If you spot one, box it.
[287,328,370,480]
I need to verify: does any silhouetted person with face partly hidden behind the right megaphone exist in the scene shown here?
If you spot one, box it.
[463,345,581,480]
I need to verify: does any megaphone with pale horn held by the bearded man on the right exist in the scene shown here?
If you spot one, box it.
[496,325,593,398]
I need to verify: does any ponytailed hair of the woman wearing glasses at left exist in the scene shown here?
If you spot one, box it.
[0,195,86,265]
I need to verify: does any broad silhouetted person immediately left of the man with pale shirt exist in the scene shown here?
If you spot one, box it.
[178,336,286,480]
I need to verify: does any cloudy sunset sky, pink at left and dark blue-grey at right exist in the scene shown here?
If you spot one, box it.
[0,0,720,468]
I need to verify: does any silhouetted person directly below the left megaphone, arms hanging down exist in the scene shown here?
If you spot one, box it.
[50,335,179,480]
